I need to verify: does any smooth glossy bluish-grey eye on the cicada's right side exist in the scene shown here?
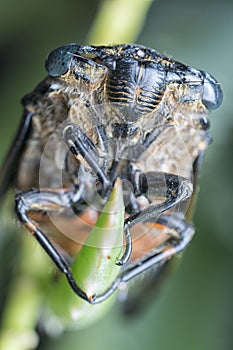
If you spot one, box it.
[201,71,223,110]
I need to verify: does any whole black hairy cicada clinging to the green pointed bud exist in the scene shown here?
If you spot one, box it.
[0,44,222,304]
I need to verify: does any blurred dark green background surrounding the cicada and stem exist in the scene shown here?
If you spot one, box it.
[0,0,233,350]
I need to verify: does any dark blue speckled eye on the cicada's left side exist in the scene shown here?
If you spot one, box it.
[45,44,79,77]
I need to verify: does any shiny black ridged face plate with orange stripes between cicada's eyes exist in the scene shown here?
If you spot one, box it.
[105,58,165,122]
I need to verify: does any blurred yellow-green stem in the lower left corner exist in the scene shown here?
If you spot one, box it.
[0,237,49,350]
